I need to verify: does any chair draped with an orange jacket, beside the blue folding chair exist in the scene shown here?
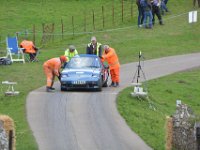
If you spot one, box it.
[20,40,39,62]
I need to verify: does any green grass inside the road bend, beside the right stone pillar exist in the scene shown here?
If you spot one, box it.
[117,69,200,150]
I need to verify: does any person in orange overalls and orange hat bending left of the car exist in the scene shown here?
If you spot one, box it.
[43,56,67,92]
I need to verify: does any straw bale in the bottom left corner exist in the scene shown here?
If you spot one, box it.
[0,115,16,150]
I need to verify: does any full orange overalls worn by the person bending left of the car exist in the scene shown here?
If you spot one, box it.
[43,57,62,87]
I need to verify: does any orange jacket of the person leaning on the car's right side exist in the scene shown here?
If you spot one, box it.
[102,47,120,69]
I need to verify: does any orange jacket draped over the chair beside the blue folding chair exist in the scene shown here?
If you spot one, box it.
[20,40,36,54]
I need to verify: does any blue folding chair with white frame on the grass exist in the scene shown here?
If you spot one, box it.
[6,37,25,63]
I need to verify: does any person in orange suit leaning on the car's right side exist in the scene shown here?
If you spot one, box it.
[101,45,120,87]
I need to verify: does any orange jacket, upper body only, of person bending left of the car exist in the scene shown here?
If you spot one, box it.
[43,58,62,76]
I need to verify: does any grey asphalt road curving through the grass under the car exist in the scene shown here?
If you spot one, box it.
[26,53,200,150]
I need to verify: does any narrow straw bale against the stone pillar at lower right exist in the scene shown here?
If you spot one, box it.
[165,116,173,150]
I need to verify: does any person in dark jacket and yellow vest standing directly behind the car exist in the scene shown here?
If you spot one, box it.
[86,36,102,57]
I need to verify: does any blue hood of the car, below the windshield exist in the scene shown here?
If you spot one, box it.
[62,68,101,77]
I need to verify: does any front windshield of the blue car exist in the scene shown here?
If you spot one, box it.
[67,57,100,68]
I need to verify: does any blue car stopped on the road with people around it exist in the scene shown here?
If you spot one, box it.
[60,54,109,91]
